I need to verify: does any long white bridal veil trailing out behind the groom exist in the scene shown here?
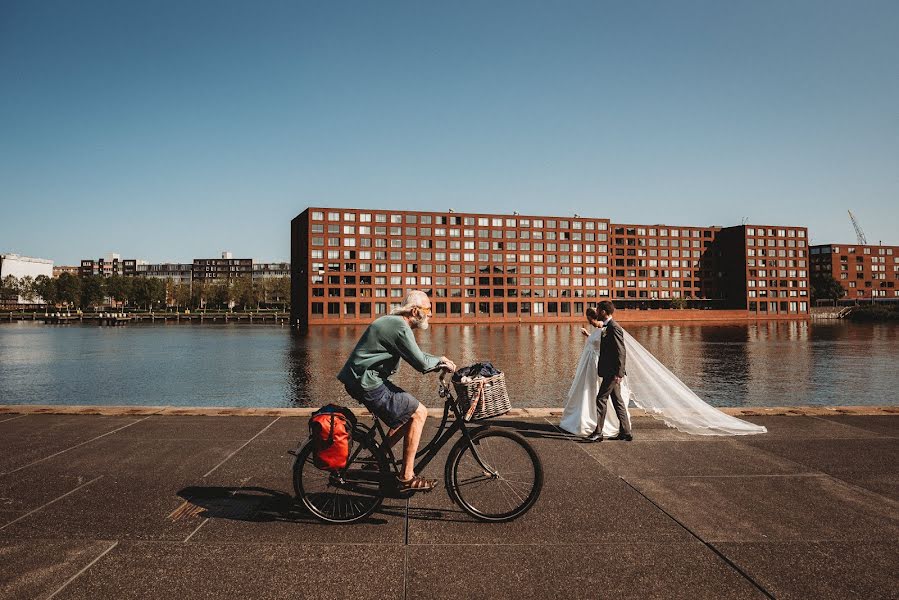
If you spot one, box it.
[624,331,767,435]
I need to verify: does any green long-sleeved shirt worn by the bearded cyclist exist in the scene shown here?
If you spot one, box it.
[337,315,440,394]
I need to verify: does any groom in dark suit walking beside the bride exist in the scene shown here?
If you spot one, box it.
[587,300,634,442]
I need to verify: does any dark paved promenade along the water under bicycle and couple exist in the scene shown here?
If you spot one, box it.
[0,406,899,600]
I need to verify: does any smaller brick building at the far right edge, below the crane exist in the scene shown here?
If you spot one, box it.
[811,244,899,301]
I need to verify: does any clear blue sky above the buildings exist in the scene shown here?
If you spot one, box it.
[0,0,899,264]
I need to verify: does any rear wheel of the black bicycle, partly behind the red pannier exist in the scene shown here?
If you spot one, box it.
[293,432,388,523]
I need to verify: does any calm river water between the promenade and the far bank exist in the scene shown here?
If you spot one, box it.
[0,322,899,407]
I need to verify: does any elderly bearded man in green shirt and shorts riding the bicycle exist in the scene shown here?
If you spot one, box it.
[337,290,456,491]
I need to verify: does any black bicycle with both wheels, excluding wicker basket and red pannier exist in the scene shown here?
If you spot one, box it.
[293,374,543,523]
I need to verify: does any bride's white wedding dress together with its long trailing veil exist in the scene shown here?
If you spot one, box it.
[559,329,767,437]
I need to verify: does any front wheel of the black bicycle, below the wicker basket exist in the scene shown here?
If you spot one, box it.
[447,429,543,523]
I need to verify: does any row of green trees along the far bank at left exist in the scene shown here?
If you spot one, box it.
[0,273,290,310]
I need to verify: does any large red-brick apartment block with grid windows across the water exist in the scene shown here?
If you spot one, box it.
[291,208,808,325]
